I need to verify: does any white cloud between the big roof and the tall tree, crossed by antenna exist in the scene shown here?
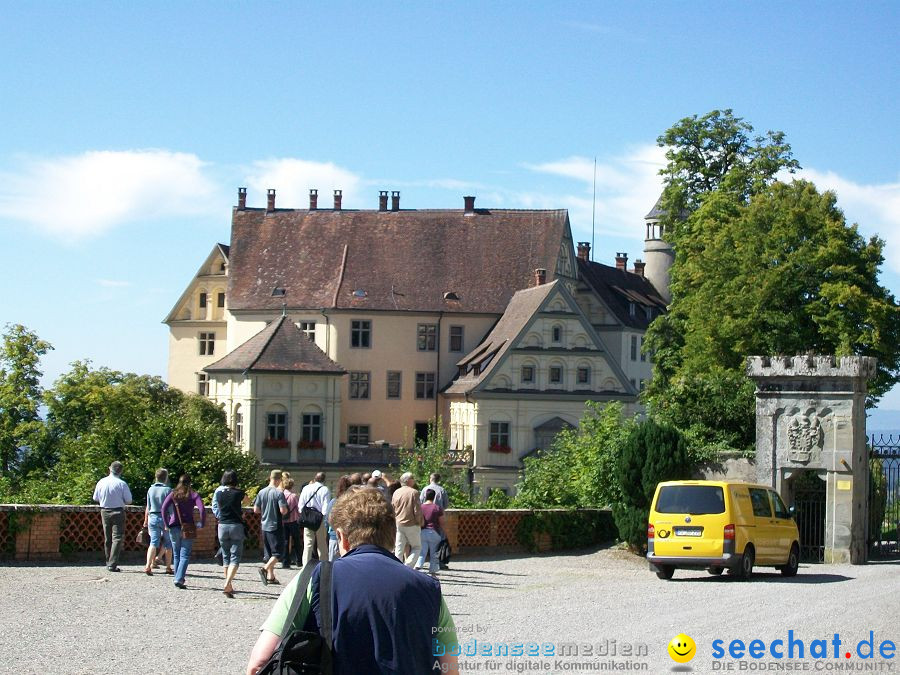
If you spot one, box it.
[517,145,665,239]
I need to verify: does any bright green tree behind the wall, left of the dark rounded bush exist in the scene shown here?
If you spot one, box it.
[515,402,633,508]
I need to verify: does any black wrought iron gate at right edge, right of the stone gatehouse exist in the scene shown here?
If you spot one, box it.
[866,435,900,559]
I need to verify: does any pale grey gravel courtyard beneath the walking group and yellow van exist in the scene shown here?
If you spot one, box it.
[0,549,900,675]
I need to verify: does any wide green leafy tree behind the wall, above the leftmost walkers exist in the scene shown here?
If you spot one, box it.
[42,362,259,504]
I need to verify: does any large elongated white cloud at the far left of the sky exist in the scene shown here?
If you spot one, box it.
[0,150,220,241]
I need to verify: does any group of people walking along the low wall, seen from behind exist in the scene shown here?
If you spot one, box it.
[94,462,449,598]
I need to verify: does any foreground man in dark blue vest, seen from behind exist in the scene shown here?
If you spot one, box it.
[247,488,459,675]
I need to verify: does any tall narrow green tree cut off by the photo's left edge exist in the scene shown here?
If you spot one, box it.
[0,324,53,482]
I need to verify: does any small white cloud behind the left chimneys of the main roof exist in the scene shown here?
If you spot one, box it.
[245,157,364,209]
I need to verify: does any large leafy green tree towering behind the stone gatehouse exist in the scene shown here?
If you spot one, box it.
[647,111,900,450]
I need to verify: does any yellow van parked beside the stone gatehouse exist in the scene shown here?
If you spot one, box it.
[647,480,800,579]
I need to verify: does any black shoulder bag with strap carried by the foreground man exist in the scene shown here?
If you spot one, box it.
[257,560,334,675]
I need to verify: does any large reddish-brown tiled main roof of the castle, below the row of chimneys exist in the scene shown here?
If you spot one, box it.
[228,209,568,314]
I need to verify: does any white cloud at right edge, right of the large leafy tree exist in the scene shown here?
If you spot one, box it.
[796,169,900,274]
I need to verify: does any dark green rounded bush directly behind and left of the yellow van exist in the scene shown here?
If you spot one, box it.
[613,419,692,551]
